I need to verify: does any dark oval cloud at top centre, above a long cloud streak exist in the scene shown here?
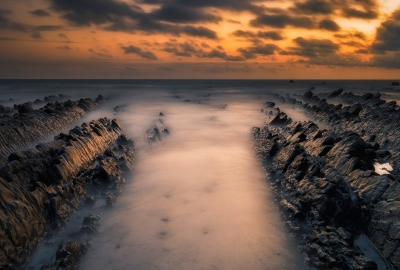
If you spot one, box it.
[151,5,222,23]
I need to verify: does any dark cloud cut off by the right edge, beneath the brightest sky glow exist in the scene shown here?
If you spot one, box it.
[372,9,400,53]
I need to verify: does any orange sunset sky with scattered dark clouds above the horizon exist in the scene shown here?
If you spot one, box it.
[0,0,400,80]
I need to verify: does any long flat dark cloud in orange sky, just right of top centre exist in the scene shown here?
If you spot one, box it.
[250,14,315,28]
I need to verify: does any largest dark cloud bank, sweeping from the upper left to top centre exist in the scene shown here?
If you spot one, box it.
[51,0,219,39]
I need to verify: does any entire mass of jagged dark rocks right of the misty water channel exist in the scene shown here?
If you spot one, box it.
[253,97,400,269]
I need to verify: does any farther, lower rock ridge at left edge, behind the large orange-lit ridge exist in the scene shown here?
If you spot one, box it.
[0,96,102,158]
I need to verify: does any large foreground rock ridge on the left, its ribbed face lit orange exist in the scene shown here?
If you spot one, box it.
[0,118,133,270]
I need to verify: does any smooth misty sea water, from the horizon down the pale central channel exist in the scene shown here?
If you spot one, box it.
[0,81,395,270]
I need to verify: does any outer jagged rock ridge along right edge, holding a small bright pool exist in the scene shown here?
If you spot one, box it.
[268,91,400,269]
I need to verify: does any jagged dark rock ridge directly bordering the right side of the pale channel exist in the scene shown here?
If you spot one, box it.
[253,119,376,269]
